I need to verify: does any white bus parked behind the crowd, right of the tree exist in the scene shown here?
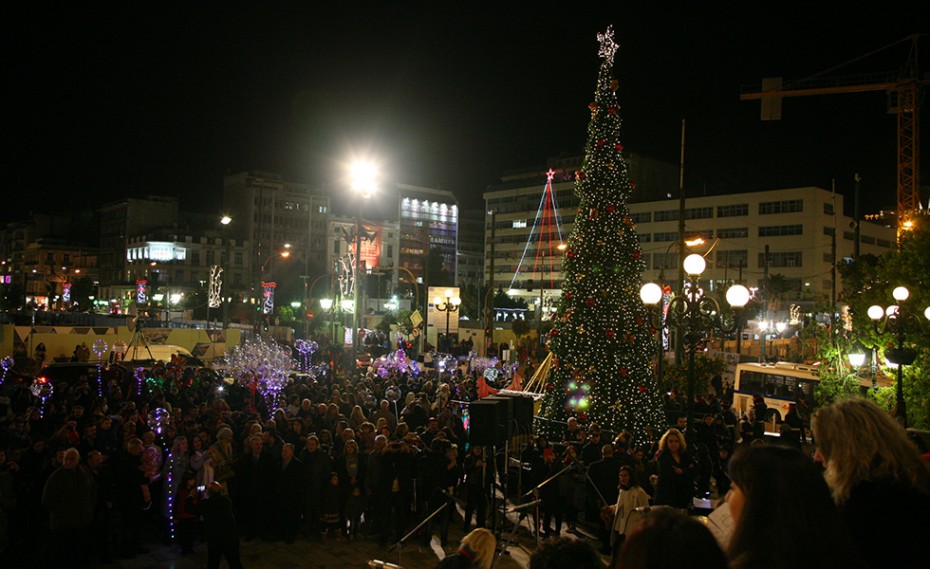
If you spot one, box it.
[733,362,820,433]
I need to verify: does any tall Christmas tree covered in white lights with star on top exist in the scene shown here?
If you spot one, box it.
[537,28,665,442]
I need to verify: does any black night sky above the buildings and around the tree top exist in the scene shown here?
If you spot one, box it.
[0,0,930,221]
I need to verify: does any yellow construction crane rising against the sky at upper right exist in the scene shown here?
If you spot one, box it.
[740,34,930,244]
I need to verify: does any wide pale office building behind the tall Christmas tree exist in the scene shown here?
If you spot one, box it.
[484,158,895,308]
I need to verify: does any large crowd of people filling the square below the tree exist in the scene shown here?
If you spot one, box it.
[0,342,930,568]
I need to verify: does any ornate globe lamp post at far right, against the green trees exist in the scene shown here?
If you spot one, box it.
[867,286,930,428]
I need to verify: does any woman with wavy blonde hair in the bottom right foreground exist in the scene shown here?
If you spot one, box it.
[811,397,930,568]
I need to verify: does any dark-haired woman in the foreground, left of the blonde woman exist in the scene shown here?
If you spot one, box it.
[727,445,864,569]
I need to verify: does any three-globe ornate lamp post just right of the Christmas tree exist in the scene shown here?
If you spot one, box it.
[639,253,749,432]
